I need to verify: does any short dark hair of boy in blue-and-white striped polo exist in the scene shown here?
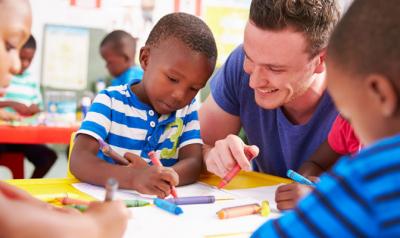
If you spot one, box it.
[146,12,217,64]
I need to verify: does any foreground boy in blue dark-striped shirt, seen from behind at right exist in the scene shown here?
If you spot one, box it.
[252,0,400,237]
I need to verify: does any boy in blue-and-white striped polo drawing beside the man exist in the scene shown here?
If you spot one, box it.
[71,13,217,197]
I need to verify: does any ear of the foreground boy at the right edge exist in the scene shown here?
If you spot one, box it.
[365,74,399,117]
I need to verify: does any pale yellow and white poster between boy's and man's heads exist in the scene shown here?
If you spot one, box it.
[203,0,250,67]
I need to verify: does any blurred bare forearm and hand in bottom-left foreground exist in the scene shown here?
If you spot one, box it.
[0,194,129,238]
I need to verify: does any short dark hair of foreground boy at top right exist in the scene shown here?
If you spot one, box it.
[328,0,400,87]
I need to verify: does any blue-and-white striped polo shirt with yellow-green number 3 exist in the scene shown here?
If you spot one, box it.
[77,81,203,166]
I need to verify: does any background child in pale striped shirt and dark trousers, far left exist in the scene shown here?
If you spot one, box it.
[0,36,57,178]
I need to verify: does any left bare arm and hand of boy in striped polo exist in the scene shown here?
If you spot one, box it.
[70,134,178,197]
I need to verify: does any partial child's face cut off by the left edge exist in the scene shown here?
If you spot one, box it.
[0,0,31,91]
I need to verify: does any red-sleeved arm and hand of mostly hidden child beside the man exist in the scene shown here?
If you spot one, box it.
[275,115,361,210]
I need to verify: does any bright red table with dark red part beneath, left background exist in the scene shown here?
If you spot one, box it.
[0,125,78,179]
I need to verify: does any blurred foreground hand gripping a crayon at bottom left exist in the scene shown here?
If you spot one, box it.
[84,201,131,238]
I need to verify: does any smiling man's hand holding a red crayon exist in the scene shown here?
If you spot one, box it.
[204,135,259,178]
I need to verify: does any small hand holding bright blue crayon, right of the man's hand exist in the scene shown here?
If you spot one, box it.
[275,183,314,210]
